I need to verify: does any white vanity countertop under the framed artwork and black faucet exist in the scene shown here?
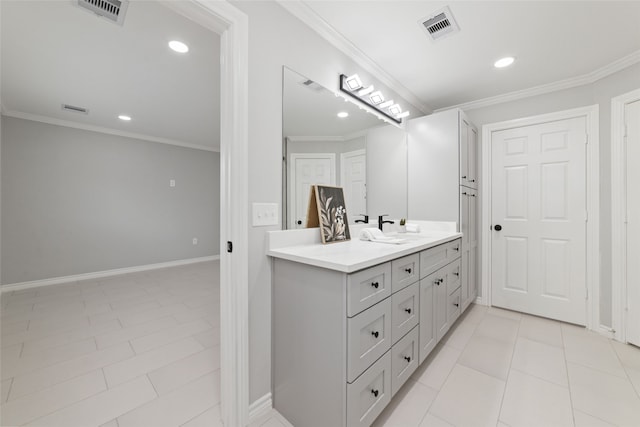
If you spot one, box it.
[267,222,462,273]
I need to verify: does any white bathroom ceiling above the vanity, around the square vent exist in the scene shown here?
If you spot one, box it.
[298,0,640,110]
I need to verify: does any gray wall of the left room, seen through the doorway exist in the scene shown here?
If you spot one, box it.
[0,117,220,284]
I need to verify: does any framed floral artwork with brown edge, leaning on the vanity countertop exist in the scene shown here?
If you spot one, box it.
[307,185,351,243]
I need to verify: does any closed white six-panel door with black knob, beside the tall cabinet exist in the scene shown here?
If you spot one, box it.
[491,117,587,325]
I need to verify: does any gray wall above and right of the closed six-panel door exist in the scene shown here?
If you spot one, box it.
[466,64,640,327]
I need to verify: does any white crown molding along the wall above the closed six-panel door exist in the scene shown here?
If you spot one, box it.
[434,50,640,113]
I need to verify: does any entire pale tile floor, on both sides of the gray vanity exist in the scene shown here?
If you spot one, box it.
[0,262,640,427]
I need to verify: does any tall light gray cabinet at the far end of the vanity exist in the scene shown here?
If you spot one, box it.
[407,109,480,310]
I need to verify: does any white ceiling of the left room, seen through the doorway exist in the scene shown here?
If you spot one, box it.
[0,0,220,149]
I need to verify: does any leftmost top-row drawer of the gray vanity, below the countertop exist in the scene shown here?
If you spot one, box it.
[347,262,391,317]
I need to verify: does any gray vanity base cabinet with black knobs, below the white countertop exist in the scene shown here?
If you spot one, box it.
[273,234,464,427]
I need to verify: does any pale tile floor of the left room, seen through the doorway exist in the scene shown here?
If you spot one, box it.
[0,262,220,427]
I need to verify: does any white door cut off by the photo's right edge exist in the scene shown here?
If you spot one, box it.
[625,101,640,346]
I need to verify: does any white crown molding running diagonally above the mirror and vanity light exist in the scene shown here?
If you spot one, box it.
[276,0,433,114]
